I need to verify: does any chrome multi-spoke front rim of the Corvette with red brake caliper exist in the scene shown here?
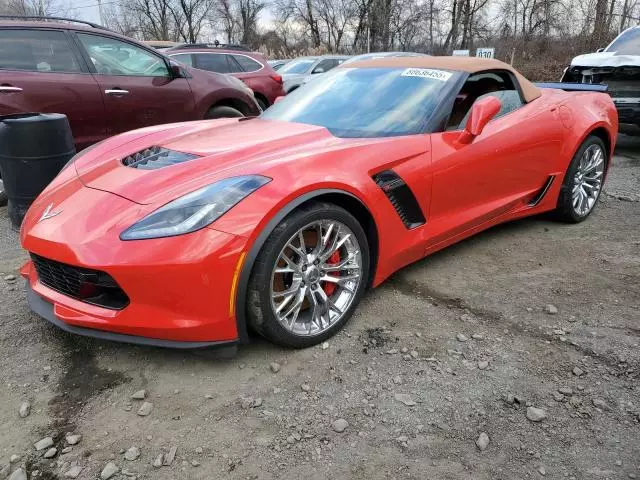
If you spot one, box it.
[270,220,362,336]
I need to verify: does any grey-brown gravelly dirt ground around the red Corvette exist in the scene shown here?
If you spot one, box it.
[0,137,640,480]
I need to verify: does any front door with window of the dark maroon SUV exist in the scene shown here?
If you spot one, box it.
[77,33,196,134]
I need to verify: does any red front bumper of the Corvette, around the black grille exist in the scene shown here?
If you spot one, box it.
[21,180,247,348]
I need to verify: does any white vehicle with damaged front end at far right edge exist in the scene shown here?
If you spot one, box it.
[561,27,640,135]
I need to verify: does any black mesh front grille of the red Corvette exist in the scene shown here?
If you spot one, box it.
[31,253,129,310]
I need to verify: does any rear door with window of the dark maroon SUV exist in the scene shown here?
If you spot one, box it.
[0,29,107,149]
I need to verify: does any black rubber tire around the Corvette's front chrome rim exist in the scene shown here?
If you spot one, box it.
[247,203,370,348]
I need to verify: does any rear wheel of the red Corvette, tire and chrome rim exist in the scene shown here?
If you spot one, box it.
[556,135,607,223]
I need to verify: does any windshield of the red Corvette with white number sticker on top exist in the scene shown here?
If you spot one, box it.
[262,68,458,137]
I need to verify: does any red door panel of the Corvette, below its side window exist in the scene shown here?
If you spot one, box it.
[428,100,563,246]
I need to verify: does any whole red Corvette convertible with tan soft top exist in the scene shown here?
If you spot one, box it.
[21,57,618,348]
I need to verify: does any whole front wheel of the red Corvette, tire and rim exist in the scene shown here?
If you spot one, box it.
[247,203,370,348]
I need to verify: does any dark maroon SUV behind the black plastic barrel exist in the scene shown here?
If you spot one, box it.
[0,18,260,149]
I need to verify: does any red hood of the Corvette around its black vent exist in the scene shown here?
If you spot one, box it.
[74,118,354,204]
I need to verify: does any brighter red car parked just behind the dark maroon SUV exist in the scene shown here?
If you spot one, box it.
[166,44,284,110]
